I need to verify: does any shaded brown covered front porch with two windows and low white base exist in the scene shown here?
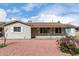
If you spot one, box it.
[31,27,66,38]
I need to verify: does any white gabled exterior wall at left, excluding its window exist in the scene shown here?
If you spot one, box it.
[4,23,31,39]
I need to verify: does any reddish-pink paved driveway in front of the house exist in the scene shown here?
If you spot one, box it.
[0,40,68,56]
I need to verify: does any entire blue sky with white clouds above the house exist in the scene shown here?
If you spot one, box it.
[0,3,79,26]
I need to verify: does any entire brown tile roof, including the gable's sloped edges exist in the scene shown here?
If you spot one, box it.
[0,21,75,28]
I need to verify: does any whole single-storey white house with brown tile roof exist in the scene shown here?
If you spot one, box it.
[0,21,75,39]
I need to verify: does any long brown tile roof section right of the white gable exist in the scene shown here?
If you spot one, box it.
[28,22,75,28]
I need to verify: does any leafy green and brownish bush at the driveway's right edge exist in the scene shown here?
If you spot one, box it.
[58,36,79,55]
